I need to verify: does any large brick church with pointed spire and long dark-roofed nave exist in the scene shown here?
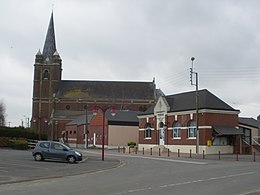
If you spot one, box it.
[31,12,161,140]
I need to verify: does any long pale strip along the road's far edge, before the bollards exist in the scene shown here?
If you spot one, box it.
[87,151,208,165]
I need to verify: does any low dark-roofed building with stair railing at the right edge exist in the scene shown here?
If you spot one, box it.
[239,117,260,154]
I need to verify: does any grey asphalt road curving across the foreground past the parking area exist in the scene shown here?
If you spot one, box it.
[0,151,260,195]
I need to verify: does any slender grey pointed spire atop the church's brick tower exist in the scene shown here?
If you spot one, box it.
[42,12,56,64]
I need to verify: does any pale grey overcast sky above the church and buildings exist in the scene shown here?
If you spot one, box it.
[0,0,260,126]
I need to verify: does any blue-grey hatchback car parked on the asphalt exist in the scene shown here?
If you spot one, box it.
[32,141,82,163]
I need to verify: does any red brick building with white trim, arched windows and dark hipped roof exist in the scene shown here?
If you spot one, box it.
[138,89,243,154]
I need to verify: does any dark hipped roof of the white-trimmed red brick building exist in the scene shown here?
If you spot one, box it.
[166,89,238,112]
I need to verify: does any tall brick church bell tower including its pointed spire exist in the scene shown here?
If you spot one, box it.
[31,12,62,139]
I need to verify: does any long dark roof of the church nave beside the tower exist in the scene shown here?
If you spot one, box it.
[57,80,155,100]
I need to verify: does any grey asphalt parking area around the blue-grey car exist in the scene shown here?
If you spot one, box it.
[0,149,120,185]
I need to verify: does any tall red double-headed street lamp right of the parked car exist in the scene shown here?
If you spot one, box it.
[92,106,116,161]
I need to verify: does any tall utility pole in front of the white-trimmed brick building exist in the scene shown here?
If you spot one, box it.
[190,57,200,154]
